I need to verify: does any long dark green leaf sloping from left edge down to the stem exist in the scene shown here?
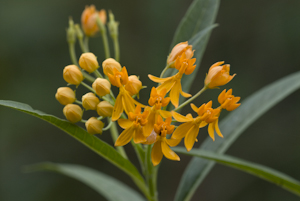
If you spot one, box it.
[0,100,148,198]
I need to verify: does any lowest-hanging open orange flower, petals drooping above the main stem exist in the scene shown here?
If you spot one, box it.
[151,116,180,166]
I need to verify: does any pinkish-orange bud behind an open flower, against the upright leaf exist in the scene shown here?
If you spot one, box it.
[167,41,194,68]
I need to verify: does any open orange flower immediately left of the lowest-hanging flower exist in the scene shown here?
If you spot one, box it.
[115,106,149,146]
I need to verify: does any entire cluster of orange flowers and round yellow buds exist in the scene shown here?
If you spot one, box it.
[55,6,240,166]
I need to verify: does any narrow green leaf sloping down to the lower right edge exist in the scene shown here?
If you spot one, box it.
[173,147,300,196]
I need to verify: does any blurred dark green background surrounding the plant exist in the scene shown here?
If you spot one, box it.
[0,0,300,201]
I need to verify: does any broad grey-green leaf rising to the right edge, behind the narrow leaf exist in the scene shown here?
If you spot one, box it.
[175,72,300,201]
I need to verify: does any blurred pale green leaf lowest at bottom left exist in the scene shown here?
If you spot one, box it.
[26,163,145,201]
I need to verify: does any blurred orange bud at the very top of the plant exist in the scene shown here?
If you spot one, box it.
[81,5,106,37]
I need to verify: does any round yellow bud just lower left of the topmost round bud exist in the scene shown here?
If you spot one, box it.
[63,65,83,85]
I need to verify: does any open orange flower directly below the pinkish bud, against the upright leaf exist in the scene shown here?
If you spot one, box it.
[148,53,196,108]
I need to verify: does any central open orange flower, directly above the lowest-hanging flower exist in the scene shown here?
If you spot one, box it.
[145,87,172,135]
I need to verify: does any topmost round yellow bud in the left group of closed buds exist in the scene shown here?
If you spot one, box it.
[79,52,99,73]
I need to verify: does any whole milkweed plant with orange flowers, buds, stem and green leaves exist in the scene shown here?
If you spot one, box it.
[0,0,300,201]
